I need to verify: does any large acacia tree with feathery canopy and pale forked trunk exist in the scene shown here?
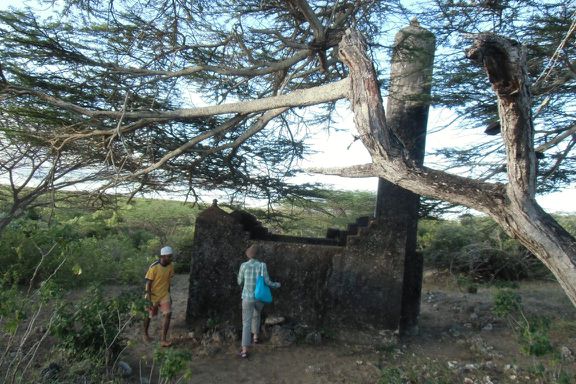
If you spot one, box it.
[0,0,576,304]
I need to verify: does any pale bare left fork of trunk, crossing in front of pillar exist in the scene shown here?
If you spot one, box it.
[330,30,505,216]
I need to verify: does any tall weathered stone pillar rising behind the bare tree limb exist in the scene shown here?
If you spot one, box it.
[375,20,435,333]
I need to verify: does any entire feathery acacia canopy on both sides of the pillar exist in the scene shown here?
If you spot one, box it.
[0,0,576,207]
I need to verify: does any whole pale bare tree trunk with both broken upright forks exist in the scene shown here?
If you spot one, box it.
[338,31,576,306]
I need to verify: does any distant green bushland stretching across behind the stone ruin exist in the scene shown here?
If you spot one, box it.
[0,191,576,289]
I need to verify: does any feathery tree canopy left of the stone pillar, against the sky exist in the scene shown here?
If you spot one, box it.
[0,1,392,204]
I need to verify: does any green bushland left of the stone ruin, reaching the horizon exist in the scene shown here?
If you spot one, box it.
[0,200,198,287]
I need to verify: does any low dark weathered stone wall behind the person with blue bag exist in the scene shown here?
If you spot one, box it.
[187,206,405,330]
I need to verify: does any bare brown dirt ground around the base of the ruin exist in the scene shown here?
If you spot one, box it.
[123,275,576,384]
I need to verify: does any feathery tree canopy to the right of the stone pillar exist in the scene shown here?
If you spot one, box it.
[418,1,576,192]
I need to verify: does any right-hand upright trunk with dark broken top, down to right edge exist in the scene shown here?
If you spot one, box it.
[467,34,576,305]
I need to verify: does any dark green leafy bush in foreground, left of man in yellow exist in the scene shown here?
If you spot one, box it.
[50,288,145,362]
